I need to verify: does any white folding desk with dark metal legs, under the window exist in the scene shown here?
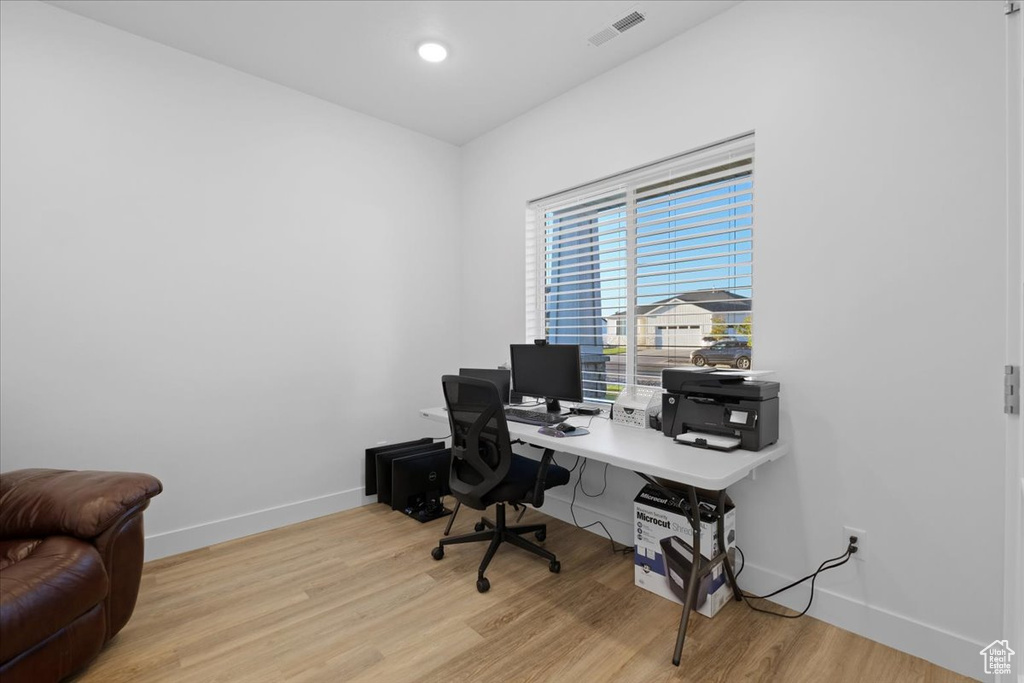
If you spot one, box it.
[420,408,790,667]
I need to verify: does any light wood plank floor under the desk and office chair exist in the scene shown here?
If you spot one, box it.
[76,505,969,683]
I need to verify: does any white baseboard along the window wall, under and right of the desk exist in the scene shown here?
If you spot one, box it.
[542,492,986,679]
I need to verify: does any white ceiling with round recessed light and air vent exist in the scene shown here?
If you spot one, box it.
[49,0,736,145]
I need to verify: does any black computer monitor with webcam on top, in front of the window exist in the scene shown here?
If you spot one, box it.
[509,344,583,413]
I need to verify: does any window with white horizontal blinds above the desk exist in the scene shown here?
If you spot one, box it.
[526,135,754,400]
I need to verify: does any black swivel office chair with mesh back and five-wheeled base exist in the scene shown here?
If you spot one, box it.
[430,375,569,593]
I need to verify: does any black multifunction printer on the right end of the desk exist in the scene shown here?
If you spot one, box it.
[662,368,778,451]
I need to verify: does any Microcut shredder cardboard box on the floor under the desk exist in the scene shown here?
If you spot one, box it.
[633,484,736,616]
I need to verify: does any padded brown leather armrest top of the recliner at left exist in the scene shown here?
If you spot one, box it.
[0,469,163,540]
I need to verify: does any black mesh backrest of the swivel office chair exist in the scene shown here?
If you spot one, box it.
[441,375,512,510]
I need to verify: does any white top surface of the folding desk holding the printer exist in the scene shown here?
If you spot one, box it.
[420,408,790,490]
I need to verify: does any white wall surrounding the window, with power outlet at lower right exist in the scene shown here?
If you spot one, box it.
[461,1,1006,676]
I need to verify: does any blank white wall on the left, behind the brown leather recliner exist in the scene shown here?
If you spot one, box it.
[0,2,460,558]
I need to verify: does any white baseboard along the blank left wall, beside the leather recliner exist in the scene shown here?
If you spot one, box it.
[145,487,364,562]
